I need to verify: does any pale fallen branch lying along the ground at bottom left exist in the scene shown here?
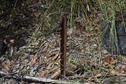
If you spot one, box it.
[0,71,77,84]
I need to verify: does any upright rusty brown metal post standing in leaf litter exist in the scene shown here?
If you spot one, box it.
[60,15,67,77]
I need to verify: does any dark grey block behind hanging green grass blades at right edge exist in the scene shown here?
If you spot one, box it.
[101,22,126,56]
